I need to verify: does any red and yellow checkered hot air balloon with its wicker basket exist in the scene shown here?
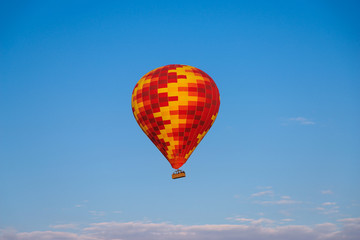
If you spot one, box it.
[131,64,220,179]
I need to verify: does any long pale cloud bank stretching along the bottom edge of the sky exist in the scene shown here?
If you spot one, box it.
[0,221,360,240]
